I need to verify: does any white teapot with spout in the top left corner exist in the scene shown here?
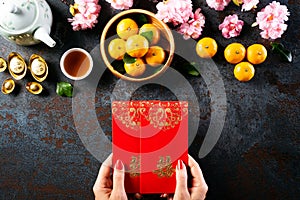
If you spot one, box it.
[0,0,56,47]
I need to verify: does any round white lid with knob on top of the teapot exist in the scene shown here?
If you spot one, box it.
[0,0,38,32]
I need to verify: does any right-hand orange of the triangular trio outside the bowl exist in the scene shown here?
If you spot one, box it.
[247,44,268,65]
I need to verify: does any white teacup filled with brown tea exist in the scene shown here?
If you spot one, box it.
[60,48,93,80]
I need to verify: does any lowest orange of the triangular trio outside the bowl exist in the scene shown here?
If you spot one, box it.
[233,62,255,82]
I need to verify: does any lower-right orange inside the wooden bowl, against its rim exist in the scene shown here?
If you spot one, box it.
[145,46,166,67]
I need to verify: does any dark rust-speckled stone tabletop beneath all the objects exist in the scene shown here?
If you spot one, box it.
[0,0,300,199]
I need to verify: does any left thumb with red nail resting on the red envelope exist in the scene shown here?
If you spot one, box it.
[113,160,125,192]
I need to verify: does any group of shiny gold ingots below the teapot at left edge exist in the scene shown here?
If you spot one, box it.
[0,52,48,94]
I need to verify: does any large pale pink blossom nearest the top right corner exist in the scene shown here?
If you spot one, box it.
[255,1,290,39]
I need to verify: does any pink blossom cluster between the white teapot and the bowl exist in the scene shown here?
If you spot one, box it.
[68,0,101,31]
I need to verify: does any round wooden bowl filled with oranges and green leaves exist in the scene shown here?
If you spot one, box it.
[100,9,175,82]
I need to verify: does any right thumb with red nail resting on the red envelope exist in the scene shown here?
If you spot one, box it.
[175,160,188,194]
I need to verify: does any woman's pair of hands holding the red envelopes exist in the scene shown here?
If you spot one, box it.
[93,154,208,200]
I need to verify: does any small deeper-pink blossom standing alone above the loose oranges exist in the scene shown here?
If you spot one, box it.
[219,14,244,38]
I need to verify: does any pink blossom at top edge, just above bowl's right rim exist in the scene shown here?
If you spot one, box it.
[156,0,193,26]
